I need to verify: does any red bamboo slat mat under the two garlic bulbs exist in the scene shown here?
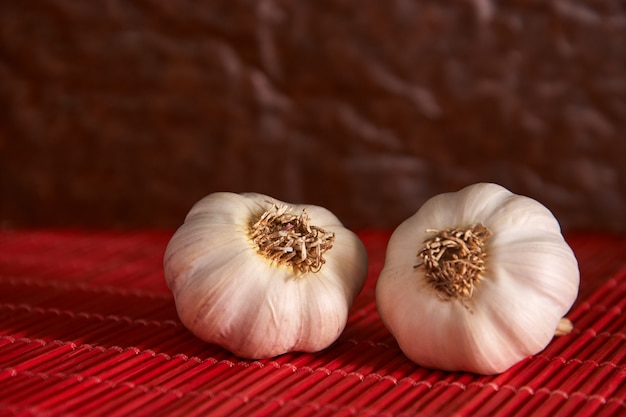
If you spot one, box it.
[0,230,626,417]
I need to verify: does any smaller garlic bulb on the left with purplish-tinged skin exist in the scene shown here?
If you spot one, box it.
[163,193,367,358]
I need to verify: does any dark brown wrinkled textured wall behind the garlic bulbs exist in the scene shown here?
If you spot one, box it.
[0,0,626,230]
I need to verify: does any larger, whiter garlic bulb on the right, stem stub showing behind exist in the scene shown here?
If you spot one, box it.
[376,183,579,374]
